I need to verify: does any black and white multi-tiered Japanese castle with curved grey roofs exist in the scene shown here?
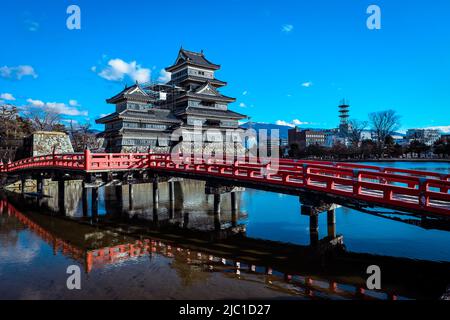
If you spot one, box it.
[96,48,247,153]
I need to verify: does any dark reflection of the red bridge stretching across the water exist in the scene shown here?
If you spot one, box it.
[0,184,450,299]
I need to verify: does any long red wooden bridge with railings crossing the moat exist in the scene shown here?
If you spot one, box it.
[0,150,450,217]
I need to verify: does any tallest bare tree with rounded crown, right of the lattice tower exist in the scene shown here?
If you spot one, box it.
[369,110,400,151]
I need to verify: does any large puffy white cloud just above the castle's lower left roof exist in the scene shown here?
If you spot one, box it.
[97,59,151,83]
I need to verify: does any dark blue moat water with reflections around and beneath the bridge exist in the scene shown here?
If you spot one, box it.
[0,162,450,299]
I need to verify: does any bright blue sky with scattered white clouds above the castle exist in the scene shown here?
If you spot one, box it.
[0,0,450,130]
